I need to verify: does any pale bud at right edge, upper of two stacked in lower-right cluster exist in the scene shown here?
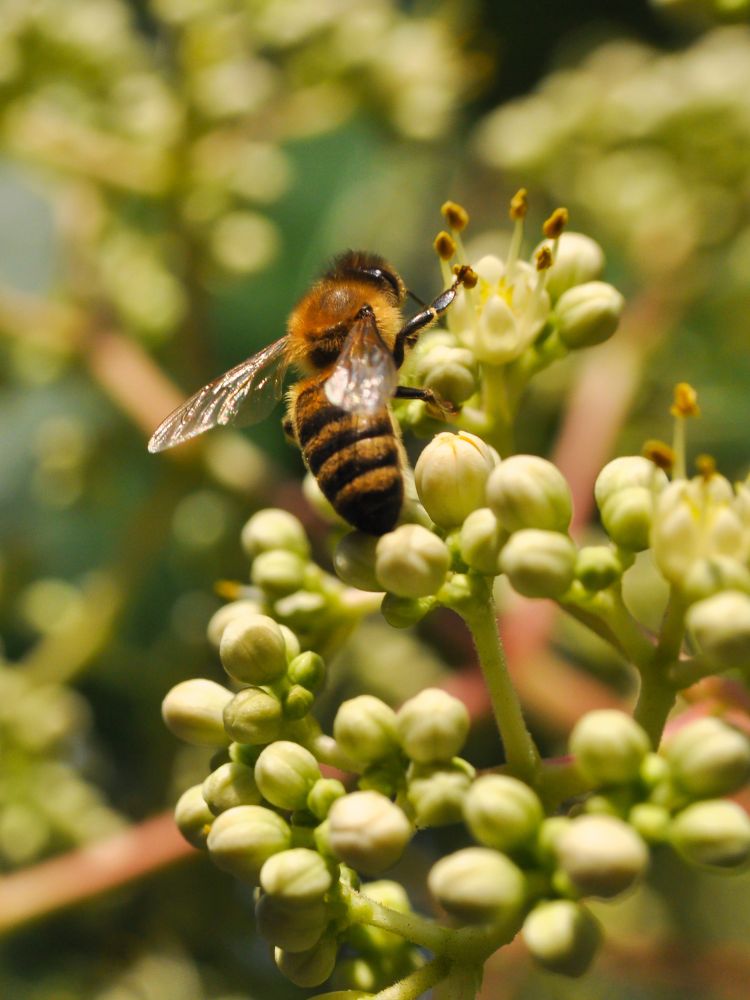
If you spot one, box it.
[664,717,750,799]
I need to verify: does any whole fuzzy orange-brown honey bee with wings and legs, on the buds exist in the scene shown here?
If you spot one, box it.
[148,251,469,535]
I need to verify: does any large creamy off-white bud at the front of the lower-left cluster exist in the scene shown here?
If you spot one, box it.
[328,791,413,875]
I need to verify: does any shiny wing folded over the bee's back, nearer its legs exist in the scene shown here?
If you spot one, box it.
[325,312,398,414]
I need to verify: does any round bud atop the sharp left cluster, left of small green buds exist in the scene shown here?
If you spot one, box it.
[219,615,287,684]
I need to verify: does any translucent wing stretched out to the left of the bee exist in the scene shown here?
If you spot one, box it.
[148,337,287,452]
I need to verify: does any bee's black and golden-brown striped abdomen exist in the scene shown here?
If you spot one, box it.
[292,377,404,535]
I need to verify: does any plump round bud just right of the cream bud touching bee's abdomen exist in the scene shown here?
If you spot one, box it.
[487,455,573,534]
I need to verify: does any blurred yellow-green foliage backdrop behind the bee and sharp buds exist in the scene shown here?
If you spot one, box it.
[0,0,750,1000]
